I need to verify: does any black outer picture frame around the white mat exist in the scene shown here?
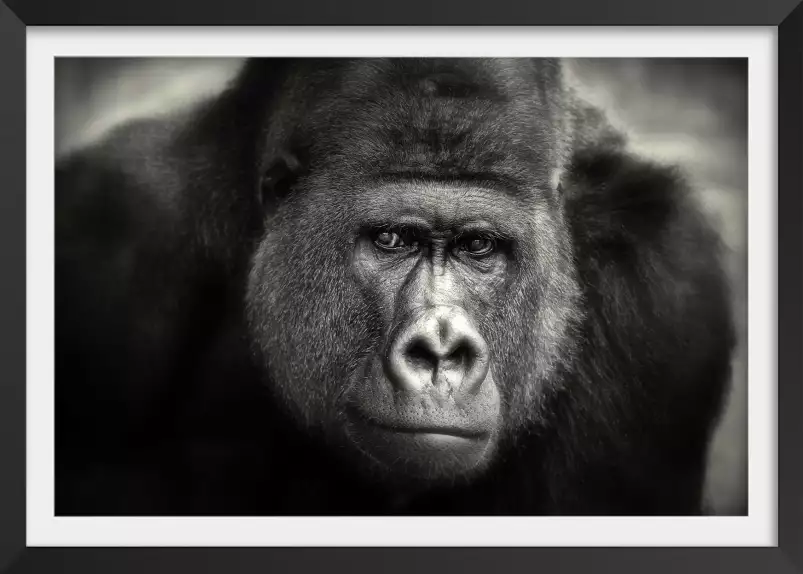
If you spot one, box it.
[0,0,803,574]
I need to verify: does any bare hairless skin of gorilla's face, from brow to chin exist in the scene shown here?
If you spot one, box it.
[349,182,510,477]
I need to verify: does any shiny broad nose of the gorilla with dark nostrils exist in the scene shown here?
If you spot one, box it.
[385,306,490,394]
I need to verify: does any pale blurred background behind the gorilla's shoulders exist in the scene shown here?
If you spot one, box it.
[55,58,748,515]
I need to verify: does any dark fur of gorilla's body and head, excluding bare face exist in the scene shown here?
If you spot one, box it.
[56,60,733,514]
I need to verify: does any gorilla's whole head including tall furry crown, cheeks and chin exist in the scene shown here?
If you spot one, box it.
[246,60,592,481]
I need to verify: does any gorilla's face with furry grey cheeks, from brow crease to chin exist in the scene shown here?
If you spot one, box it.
[248,176,577,481]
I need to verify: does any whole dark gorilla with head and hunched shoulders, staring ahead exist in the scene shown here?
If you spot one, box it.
[55,58,734,515]
